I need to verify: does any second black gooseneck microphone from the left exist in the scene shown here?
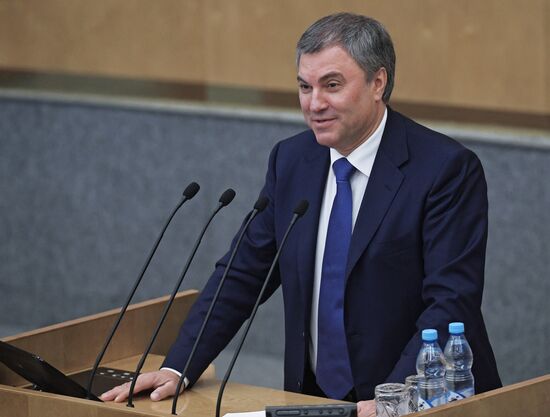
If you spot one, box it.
[126,188,235,407]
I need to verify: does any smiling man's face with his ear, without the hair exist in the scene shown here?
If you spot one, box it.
[298,46,386,155]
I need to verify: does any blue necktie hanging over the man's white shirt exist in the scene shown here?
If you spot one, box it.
[316,158,355,399]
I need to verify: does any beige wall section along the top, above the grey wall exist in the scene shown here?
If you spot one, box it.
[0,0,550,115]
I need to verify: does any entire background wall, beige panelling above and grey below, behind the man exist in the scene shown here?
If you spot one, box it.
[0,0,550,394]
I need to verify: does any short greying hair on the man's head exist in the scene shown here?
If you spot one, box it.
[296,13,395,103]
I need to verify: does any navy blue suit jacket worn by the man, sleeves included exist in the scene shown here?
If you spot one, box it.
[164,109,501,400]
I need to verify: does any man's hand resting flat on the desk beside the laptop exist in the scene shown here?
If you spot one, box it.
[101,369,184,403]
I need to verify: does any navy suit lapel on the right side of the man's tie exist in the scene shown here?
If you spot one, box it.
[346,108,408,277]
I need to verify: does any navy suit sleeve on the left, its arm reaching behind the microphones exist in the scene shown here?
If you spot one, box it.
[162,146,280,385]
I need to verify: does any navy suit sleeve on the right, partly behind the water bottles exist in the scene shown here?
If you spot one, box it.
[387,149,490,382]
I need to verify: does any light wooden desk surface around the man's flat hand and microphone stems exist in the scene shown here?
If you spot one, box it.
[0,355,344,417]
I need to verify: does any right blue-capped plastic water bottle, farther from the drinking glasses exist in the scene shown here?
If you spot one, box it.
[445,323,474,402]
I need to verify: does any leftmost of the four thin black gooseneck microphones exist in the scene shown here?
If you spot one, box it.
[86,182,200,399]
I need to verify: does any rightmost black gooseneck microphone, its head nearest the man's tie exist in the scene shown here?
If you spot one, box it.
[216,200,309,417]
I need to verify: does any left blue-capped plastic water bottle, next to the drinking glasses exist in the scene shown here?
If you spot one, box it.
[416,329,447,411]
